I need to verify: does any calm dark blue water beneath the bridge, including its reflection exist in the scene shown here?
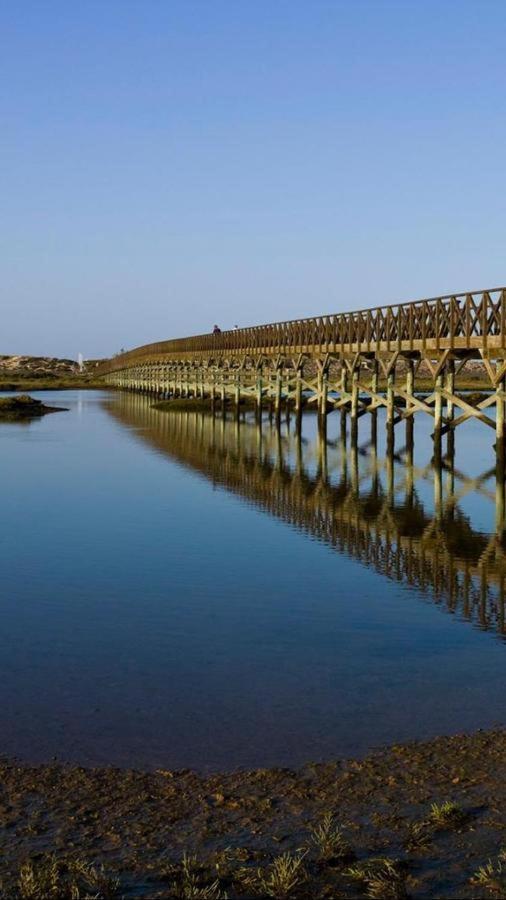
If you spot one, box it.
[0,392,506,769]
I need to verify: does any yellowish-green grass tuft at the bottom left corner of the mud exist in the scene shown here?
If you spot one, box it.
[17,855,120,900]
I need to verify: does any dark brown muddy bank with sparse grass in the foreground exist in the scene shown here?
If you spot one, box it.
[0,731,506,900]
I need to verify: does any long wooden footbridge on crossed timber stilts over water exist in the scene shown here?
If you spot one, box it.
[100,288,506,460]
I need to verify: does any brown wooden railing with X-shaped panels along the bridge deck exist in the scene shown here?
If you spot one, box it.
[101,287,506,373]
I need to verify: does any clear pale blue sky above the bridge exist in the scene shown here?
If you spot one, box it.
[0,0,506,357]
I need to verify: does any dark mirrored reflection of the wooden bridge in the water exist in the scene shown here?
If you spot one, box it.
[107,392,506,636]
